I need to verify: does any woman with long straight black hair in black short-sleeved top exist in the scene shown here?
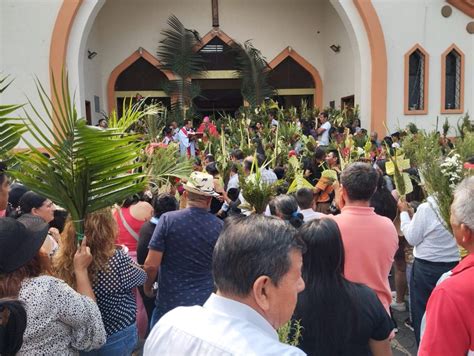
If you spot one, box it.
[295,218,393,356]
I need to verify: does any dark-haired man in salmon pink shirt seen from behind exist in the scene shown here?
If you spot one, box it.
[334,162,398,312]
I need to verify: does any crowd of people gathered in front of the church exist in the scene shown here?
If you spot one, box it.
[0,112,474,356]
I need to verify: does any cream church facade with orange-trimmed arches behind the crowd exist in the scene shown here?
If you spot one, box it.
[0,0,474,135]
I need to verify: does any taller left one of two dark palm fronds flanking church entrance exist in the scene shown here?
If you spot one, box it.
[157,15,205,122]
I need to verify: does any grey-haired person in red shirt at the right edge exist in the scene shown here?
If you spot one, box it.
[418,176,474,356]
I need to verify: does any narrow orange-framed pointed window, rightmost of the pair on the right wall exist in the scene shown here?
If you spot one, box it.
[441,45,464,114]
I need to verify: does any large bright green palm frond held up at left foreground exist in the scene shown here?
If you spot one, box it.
[11,75,147,239]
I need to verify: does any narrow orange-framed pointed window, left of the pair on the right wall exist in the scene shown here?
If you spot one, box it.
[404,45,429,115]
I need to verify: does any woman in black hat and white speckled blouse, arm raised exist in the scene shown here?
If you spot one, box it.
[0,218,106,355]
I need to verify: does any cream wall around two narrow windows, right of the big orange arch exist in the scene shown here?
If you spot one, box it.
[373,0,474,135]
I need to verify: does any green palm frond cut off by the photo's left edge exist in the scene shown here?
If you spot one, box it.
[0,76,26,156]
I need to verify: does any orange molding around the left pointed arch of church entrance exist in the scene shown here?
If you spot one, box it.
[107,47,175,113]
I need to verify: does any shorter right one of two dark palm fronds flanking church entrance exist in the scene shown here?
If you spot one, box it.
[234,40,275,107]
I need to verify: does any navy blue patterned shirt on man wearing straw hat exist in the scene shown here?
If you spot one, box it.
[148,208,223,318]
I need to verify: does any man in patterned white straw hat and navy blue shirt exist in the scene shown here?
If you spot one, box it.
[144,172,223,327]
